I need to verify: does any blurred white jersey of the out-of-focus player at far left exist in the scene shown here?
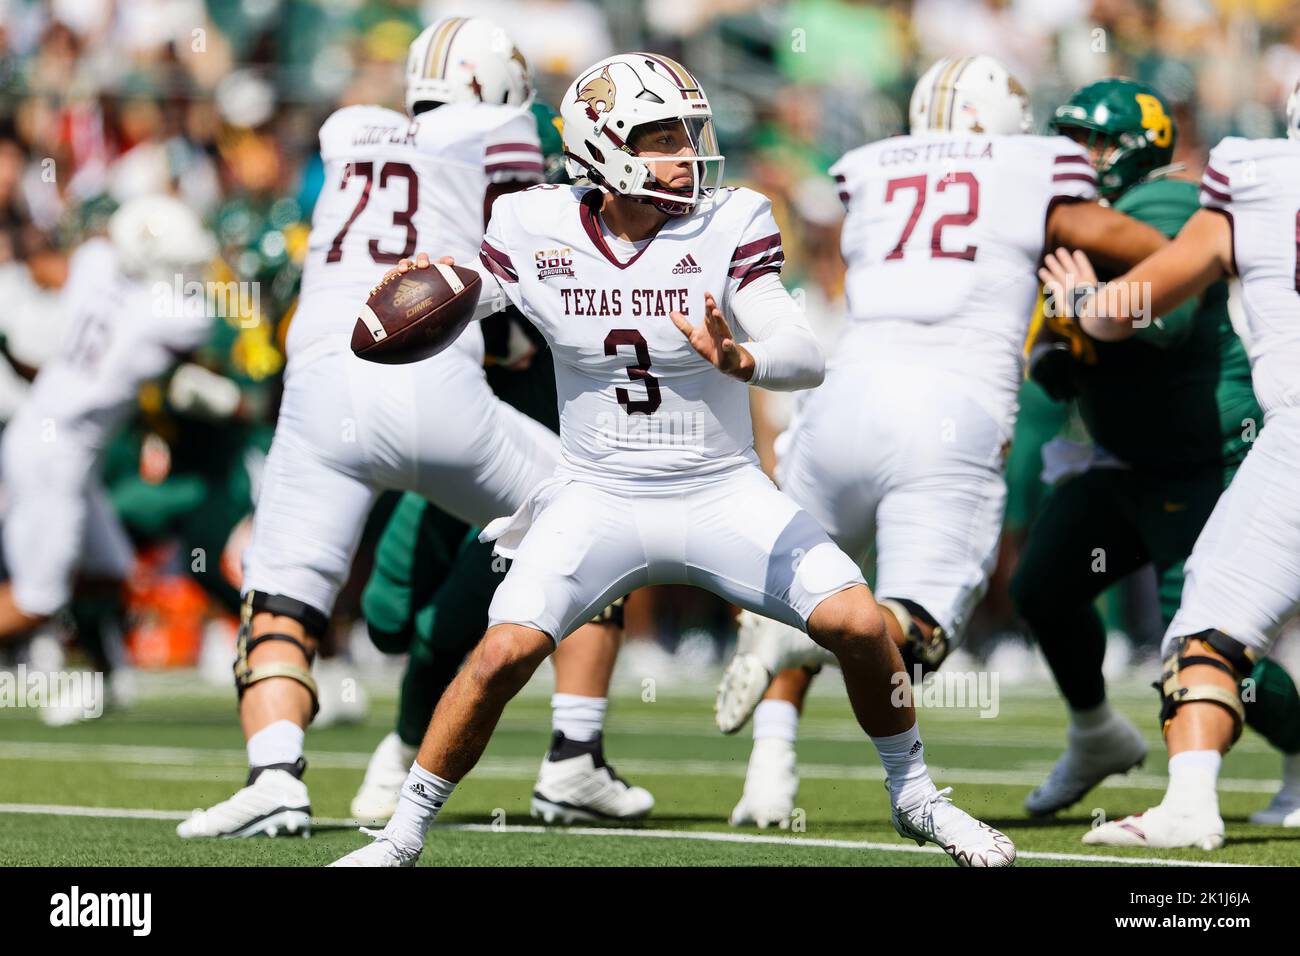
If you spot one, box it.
[10,238,212,451]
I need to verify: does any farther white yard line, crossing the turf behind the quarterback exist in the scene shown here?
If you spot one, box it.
[0,740,1281,793]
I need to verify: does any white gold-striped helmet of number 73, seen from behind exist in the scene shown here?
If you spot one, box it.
[407,17,533,116]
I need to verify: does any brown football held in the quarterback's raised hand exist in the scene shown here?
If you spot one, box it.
[352,263,482,365]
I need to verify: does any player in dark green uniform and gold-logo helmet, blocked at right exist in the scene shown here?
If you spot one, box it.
[1011,79,1300,825]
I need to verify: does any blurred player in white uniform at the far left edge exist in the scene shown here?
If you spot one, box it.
[0,195,217,650]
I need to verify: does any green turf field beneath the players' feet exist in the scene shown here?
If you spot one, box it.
[0,675,1300,866]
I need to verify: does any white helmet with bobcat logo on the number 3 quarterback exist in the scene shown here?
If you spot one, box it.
[560,53,723,216]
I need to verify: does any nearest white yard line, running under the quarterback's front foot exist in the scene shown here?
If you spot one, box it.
[0,804,1247,866]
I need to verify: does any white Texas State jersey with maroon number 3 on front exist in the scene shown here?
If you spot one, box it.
[480,186,785,481]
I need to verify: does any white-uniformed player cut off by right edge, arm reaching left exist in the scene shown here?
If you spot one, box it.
[1043,86,1300,849]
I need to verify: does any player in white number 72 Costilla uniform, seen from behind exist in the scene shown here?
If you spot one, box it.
[718,56,1166,825]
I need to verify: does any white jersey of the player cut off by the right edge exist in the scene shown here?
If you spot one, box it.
[1201,137,1300,412]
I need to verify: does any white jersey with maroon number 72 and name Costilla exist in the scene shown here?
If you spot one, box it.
[831,135,1097,413]
